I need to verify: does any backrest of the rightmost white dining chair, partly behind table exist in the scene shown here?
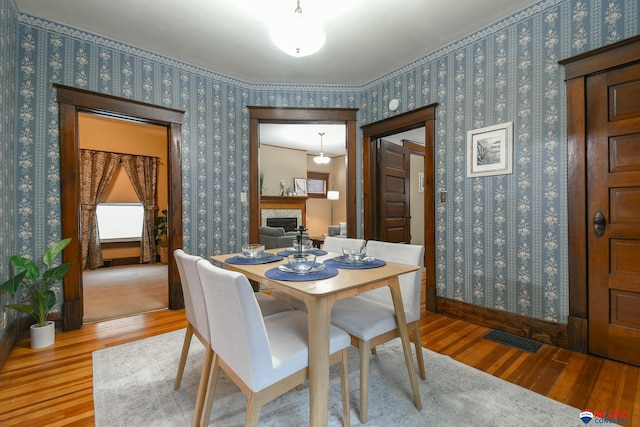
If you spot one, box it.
[366,240,424,322]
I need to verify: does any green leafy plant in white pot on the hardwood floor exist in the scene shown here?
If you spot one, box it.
[0,238,71,348]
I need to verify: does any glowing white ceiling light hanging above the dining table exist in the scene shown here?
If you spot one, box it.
[269,0,326,57]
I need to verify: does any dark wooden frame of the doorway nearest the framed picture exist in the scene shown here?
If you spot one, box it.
[362,104,437,312]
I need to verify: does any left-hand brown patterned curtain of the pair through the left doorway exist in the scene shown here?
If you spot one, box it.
[80,150,121,270]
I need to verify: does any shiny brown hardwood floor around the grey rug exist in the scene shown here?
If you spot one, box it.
[0,310,640,426]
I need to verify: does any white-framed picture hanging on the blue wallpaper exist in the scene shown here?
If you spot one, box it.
[467,122,513,178]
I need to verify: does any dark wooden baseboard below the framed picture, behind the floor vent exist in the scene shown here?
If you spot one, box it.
[436,297,569,348]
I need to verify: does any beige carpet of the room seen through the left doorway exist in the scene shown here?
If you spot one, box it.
[82,263,169,322]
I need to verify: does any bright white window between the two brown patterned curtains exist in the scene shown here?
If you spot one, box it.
[96,203,144,242]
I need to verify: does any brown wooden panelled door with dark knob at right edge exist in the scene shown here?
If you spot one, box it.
[587,64,640,365]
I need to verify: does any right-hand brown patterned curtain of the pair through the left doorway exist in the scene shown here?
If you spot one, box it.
[122,155,158,263]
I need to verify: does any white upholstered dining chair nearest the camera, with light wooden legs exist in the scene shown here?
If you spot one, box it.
[197,262,350,426]
